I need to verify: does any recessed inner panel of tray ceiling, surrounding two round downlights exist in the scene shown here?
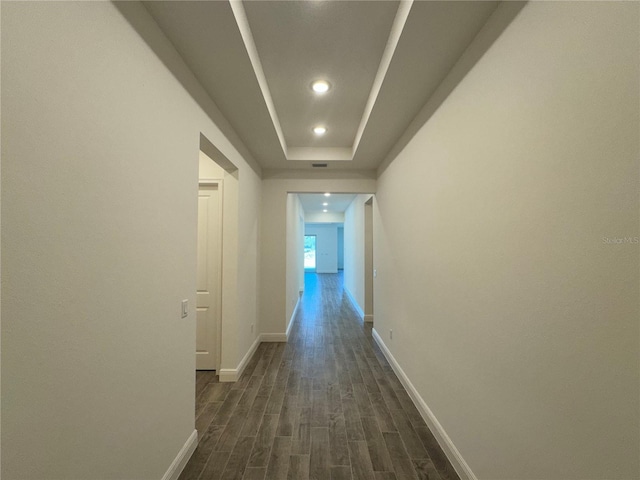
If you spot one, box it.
[244,1,398,149]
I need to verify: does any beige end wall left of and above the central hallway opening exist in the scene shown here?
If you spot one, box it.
[260,174,376,334]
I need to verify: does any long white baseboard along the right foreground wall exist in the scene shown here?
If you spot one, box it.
[373,328,478,480]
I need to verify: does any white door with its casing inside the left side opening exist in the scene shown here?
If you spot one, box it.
[196,181,222,370]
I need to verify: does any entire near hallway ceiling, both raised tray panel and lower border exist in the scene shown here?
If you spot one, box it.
[144,0,498,170]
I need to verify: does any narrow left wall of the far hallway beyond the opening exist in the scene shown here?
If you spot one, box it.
[286,193,305,332]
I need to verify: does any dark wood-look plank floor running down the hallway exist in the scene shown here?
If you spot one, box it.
[180,274,459,480]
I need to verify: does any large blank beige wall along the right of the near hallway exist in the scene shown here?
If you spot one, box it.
[376,2,640,480]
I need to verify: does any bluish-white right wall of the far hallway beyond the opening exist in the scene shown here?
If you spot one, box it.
[344,194,371,313]
